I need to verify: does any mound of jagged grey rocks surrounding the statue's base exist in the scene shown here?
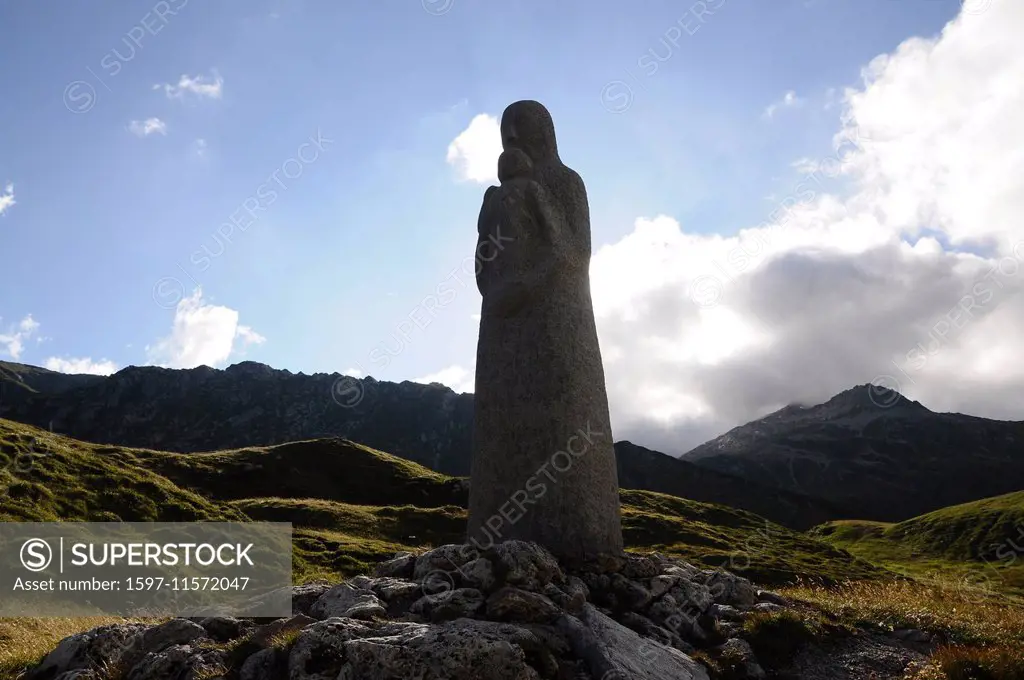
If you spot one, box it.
[24,542,930,680]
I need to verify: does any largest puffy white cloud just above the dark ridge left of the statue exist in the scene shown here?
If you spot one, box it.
[145,288,266,369]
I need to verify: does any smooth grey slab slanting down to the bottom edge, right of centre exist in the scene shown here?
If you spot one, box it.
[558,605,709,680]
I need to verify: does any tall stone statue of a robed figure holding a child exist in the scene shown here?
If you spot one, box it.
[469,96,623,562]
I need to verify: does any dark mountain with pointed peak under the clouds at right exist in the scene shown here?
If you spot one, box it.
[683,385,1024,521]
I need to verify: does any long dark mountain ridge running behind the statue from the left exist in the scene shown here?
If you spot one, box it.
[0,362,841,529]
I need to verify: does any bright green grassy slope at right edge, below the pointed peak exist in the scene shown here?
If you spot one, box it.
[811,492,1024,597]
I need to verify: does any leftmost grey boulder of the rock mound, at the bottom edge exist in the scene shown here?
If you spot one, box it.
[24,624,147,680]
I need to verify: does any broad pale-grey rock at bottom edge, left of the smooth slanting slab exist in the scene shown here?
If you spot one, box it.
[342,620,541,680]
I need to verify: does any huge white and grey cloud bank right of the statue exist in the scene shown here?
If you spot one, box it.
[591,2,1024,454]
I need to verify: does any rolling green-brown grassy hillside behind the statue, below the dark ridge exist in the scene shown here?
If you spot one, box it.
[0,420,884,584]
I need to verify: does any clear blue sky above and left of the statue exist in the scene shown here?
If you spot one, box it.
[8,0,1024,450]
